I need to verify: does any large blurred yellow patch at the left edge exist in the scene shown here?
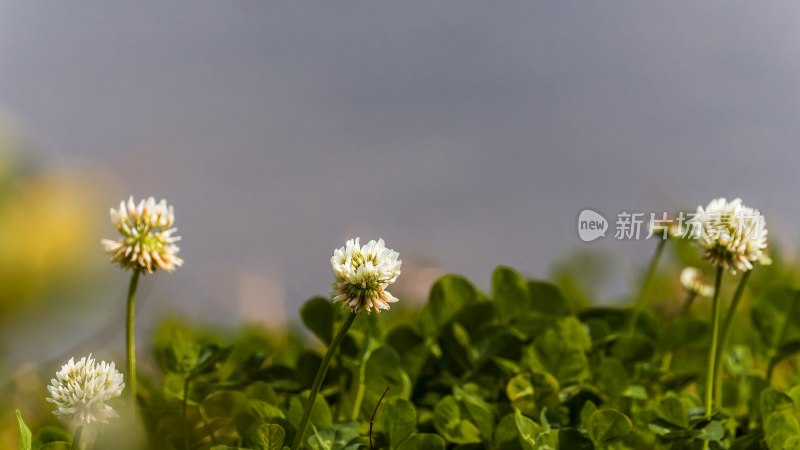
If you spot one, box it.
[0,122,102,315]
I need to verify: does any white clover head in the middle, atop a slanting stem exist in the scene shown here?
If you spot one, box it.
[331,238,403,314]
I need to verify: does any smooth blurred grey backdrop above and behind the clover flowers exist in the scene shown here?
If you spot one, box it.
[0,0,800,362]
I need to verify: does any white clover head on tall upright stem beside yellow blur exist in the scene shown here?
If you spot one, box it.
[101,197,183,273]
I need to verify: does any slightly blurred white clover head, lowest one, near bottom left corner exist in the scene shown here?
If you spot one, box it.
[47,355,125,426]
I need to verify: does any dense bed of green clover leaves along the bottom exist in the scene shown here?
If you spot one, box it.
[14,236,800,450]
